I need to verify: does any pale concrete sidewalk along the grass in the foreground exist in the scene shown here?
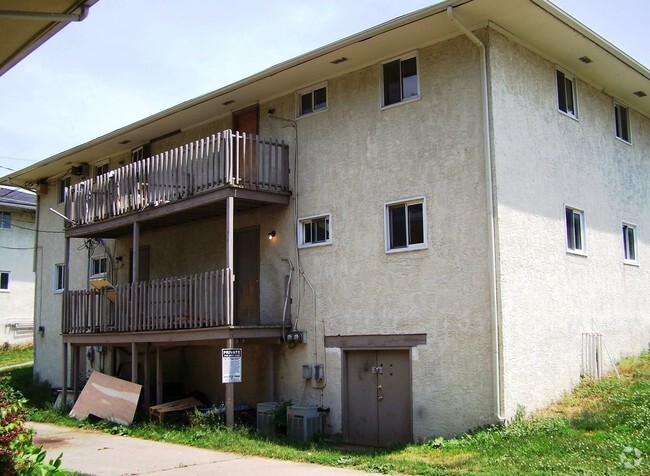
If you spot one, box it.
[28,423,367,476]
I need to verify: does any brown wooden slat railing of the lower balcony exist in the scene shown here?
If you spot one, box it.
[62,269,232,334]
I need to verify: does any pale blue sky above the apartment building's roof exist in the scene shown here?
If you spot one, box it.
[0,0,650,176]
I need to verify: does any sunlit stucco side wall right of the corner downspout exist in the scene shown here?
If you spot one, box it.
[490,31,650,417]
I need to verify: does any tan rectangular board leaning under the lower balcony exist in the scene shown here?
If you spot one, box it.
[70,372,142,425]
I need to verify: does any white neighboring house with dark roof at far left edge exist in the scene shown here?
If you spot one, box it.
[0,186,36,344]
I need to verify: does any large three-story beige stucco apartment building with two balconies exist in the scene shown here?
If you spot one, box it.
[0,0,650,446]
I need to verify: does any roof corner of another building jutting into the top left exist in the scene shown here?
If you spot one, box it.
[0,0,98,76]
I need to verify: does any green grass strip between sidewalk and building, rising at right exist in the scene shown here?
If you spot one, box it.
[7,352,650,476]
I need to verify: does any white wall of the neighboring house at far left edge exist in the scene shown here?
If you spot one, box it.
[0,207,35,344]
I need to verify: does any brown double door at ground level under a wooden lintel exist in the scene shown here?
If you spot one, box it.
[344,350,413,447]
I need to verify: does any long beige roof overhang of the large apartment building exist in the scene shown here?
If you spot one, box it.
[0,0,650,190]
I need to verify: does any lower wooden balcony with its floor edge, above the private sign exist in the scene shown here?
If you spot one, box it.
[62,268,282,344]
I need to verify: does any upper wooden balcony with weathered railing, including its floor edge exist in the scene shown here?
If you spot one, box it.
[65,130,290,237]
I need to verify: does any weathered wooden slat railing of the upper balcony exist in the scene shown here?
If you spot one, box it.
[65,130,289,225]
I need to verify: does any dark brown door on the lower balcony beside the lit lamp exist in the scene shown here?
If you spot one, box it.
[234,227,260,326]
